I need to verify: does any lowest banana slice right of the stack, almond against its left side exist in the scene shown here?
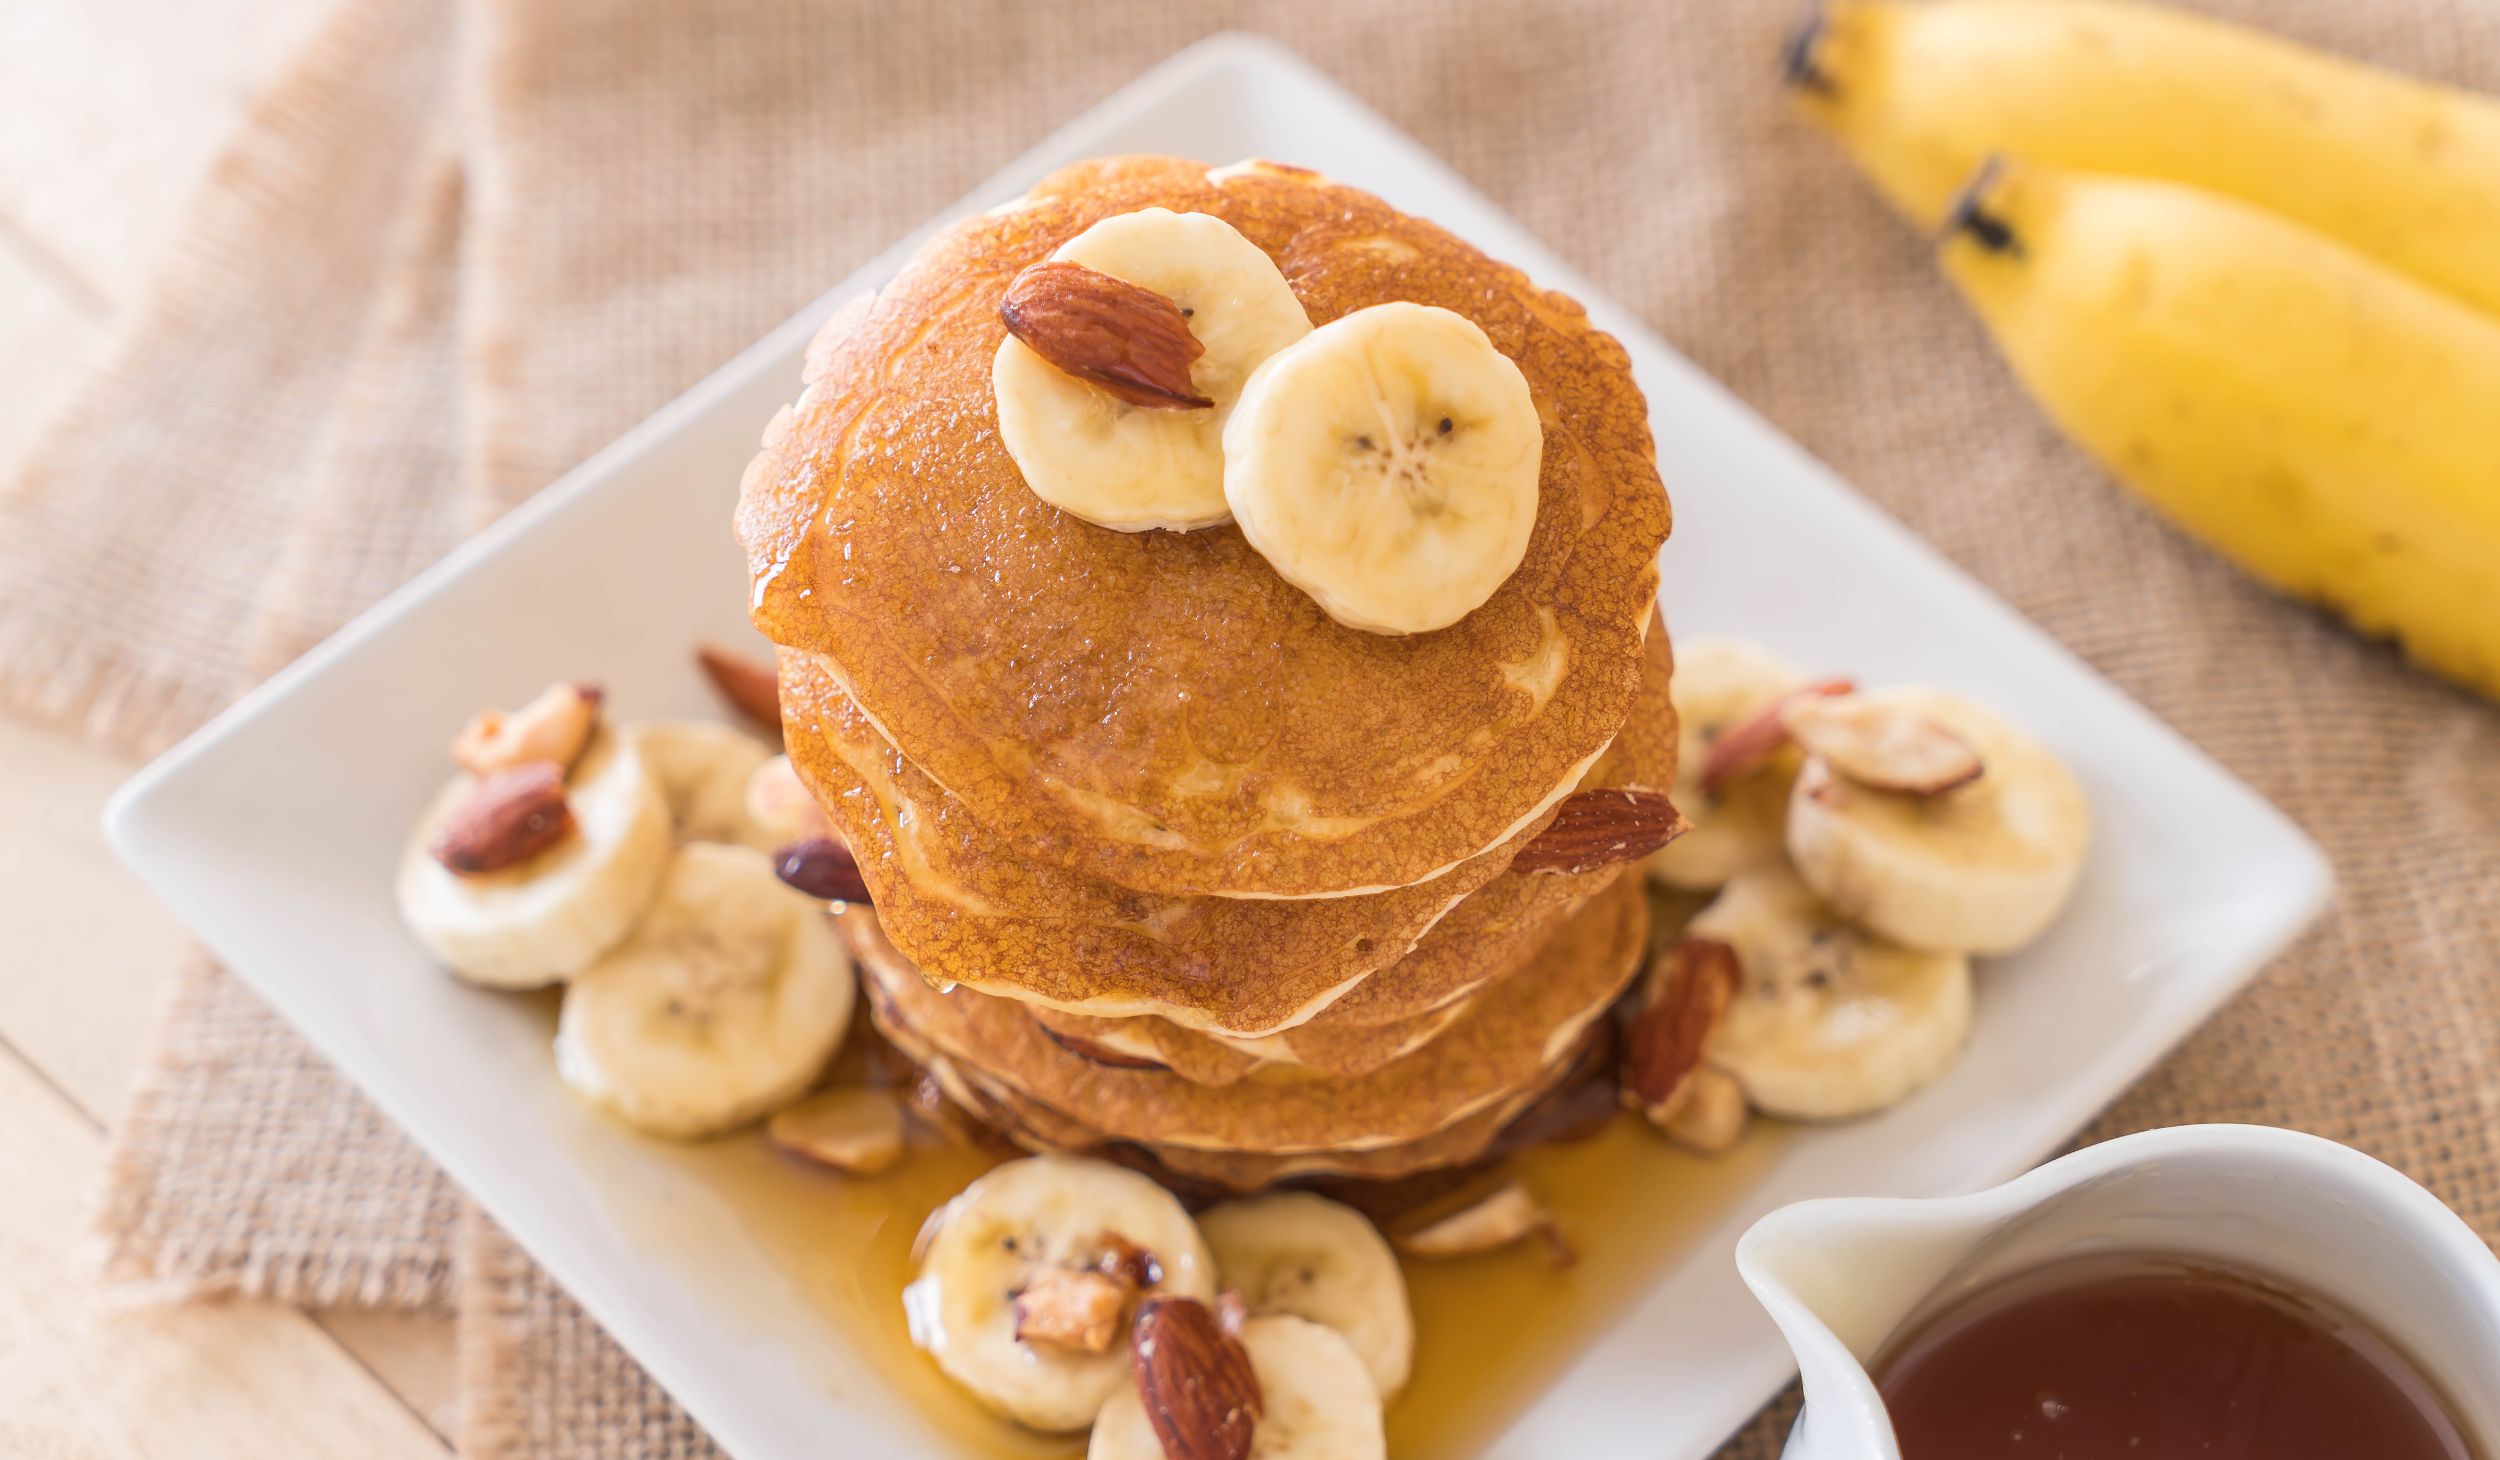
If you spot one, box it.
[1690,868,1970,1120]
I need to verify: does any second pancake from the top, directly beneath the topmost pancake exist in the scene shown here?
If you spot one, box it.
[780,615,1678,1045]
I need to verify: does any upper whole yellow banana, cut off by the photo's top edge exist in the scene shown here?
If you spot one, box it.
[1790,0,2500,315]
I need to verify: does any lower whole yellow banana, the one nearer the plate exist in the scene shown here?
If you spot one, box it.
[1940,163,2500,695]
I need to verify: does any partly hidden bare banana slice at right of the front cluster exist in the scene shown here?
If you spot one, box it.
[1198,1193,1415,1403]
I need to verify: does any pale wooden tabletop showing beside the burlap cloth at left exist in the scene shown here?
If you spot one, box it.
[0,0,455,1460]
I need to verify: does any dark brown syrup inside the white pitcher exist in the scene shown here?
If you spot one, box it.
[1873,1255,2475,1460]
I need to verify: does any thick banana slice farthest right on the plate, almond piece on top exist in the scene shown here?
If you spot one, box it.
[1788,690,2093,953]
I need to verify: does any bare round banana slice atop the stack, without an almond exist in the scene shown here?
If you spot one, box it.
[1225,303,1545,633]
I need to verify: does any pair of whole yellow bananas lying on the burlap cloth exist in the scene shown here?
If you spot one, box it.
[1788,0,2500,698]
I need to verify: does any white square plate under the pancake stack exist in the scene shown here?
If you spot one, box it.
[108,38,2328,1460]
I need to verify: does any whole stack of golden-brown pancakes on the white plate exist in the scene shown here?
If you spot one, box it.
[740,158,1675,1188]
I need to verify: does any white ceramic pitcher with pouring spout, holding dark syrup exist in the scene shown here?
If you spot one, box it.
[1735,1125,2500,1460]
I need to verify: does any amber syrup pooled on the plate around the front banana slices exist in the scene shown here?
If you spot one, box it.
[620,1095,1785,1460]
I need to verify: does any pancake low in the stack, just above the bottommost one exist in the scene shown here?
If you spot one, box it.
[843,878,1648,1155]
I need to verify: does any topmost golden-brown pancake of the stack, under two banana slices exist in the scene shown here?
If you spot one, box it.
[738,158,1668,898]
